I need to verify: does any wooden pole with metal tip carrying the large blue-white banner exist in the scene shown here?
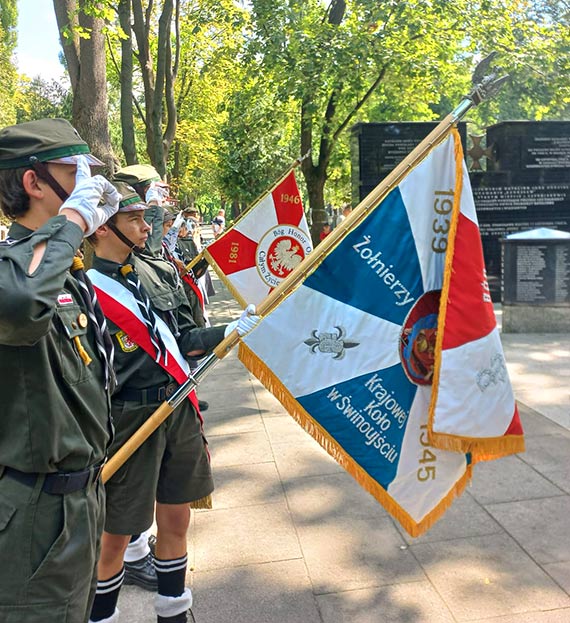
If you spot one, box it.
[101,52,508,482]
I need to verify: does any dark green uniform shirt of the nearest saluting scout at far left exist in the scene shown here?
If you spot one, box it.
[0,216,111,473]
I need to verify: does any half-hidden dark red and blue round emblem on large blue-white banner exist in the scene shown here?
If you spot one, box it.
[400,290,441,385]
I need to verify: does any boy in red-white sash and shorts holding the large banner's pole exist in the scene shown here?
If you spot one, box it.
[89,187,258,623]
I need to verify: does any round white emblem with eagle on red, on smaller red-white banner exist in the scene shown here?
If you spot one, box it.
[255,225,313,288]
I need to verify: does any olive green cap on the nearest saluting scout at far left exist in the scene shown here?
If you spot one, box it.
[0,119,105,169]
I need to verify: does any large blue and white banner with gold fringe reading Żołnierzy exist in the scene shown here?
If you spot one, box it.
[239,132,522,536]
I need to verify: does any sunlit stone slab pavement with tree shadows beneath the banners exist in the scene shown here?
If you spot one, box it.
[119,282,570,623]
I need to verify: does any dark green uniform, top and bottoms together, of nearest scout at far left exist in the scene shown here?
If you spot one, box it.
[0,219,110,623]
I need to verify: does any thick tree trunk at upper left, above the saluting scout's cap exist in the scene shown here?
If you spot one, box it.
[54,0,116,174]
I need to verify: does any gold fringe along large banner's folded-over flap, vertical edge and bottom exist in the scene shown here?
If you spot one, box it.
[428,132,524,463]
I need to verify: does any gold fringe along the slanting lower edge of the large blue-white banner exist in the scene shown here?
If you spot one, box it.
[238,342,472,537]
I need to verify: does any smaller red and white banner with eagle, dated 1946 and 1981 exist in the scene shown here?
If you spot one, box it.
[204,171,313,307]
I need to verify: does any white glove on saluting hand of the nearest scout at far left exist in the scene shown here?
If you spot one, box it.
[59,156,121,236]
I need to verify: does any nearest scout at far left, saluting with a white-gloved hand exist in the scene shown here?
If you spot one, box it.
[0,119,120,623]
